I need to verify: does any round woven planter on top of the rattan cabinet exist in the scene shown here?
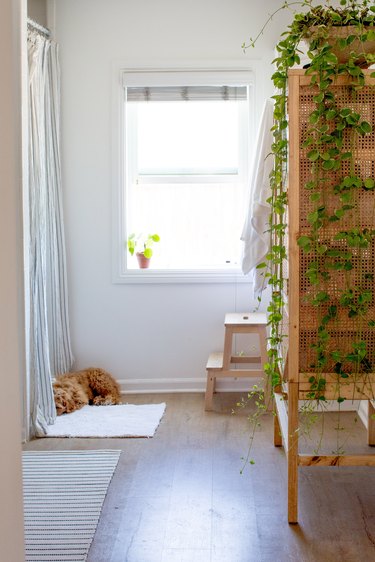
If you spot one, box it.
[305,25,375,68]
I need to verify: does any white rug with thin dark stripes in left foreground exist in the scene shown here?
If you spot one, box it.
[23,450,121,562]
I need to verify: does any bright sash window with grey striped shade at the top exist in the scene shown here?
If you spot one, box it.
[115,71,252,278]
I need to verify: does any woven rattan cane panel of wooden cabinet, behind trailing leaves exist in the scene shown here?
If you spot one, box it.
[296,80,375,386]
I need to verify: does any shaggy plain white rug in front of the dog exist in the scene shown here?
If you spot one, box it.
[45,402,165,437]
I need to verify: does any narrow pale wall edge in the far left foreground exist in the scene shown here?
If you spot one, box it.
[0,0,24,562]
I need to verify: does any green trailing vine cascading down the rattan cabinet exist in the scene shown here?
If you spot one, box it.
[239,0,375,462]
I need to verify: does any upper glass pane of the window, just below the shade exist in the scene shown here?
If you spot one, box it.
[134,101,239,175]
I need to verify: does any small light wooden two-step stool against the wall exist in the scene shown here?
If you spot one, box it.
[205,312,271,411]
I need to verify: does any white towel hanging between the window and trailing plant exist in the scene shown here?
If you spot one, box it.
[241,99,274,297]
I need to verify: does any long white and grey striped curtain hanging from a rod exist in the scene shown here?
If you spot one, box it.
[28,30,73,436]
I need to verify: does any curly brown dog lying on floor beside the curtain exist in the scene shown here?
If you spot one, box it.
[53,367,121,416]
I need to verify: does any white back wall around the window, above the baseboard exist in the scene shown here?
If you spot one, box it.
[53,0,292,390]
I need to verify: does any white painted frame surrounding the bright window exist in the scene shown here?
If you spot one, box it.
[112,68,255,283]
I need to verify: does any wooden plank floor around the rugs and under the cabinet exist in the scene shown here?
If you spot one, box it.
[25,394,375,562]
